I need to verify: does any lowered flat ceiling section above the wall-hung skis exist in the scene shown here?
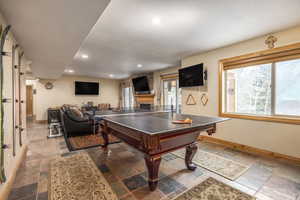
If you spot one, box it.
[0,0,110,78]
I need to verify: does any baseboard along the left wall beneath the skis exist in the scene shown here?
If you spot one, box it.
[0,144,27,200]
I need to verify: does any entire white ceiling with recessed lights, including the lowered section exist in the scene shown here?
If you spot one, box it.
[0,0,300,78]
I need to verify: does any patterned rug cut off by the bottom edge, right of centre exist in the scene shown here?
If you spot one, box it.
[175,178,256,200]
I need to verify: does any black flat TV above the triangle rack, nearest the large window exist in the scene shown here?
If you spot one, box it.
[178,63,204,88]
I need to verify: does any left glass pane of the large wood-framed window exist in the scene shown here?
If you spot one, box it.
[226,64,272,115]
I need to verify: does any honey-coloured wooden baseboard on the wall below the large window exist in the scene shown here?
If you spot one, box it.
[198,135,300,165]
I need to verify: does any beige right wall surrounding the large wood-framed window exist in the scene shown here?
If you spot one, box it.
[182,27,300,158]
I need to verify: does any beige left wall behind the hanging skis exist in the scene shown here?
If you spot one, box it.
[0,13,27,178]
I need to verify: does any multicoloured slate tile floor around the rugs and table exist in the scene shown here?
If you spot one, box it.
[9,119,300,200]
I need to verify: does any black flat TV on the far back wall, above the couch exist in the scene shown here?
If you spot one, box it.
[75,81,99,95]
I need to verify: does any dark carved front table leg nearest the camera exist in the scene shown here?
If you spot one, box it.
[145,155,161,191]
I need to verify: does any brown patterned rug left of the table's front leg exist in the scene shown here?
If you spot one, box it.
[48,152,118,200]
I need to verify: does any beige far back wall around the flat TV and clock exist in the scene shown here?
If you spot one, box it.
[34,76,119,120]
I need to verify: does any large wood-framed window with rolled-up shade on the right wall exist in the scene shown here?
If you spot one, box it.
[220,44,300,124]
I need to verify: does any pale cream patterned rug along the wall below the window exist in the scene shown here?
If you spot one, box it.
[173,149,249,180]
